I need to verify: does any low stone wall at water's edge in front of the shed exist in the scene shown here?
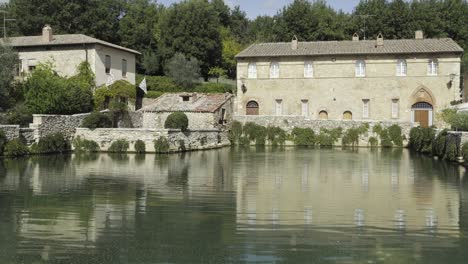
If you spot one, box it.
[75,128,230,153]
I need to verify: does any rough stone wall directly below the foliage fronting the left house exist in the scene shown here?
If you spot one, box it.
[30,113,89,141]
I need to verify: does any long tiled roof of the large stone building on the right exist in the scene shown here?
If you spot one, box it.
[236,38,463,58]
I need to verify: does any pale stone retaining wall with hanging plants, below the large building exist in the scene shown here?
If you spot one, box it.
[234,115,412,147]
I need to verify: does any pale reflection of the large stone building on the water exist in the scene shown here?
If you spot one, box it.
[237,150,459,235]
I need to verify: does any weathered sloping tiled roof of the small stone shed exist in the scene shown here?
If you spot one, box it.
[138,93,233,113]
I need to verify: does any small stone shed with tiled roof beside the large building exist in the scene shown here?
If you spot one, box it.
[138,93,234,130]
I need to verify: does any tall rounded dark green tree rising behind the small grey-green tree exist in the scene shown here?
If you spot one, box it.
[158,0,222,79]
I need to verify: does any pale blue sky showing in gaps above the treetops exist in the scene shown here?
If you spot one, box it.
[158,0,359,18]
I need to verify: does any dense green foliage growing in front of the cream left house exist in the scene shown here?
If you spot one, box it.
[24,62,94,115]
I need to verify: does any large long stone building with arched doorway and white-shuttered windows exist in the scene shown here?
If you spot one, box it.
[237,31,463,126]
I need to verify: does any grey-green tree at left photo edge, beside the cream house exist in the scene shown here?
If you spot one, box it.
[0,45,19,111]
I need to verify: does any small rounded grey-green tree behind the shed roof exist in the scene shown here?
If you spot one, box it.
[166,53,200,88]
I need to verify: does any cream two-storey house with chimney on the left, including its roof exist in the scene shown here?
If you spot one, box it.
[0,25,140,86]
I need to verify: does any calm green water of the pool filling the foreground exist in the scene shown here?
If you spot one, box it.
[0,148,468,264]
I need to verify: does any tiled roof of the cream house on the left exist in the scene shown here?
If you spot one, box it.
[0,34,141,54]
